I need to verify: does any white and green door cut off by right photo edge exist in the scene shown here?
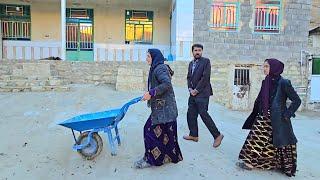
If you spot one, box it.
[310,58,320,102]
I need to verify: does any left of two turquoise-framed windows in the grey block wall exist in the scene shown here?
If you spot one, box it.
[211,2,239,31]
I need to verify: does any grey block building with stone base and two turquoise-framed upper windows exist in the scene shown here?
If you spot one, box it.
[194,0,320,110]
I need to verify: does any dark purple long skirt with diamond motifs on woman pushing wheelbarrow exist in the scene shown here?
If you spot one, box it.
[144,117,183,166]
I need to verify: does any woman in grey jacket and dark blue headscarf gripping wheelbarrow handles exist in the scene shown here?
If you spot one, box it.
[134,49,182,168]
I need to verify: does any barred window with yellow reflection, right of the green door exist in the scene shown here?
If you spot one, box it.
[125,10,153,44]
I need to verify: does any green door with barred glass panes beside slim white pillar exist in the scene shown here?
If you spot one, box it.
[66,9,94,61]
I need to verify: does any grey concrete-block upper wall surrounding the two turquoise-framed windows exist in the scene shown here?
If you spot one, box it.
[194,0,311,66]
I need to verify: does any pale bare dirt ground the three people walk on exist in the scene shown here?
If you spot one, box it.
[0,85,320,180]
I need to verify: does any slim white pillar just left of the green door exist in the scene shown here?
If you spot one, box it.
[60,0,66,60]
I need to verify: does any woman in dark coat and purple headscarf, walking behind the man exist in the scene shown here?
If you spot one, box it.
[237,59,301,177]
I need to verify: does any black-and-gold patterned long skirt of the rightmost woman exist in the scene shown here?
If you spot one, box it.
[239,113,297,176]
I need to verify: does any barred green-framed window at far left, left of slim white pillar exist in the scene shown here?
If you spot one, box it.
[0,4,31,40]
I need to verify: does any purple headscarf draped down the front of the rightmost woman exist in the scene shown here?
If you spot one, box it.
[260,59,284,116]
